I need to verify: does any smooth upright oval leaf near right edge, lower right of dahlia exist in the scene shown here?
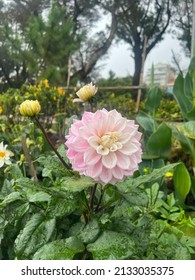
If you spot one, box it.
[173,164,191,204]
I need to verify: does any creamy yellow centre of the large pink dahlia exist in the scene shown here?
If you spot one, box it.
[97,132,122,155]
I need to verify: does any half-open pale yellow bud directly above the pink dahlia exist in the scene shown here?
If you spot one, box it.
[73,83,98,102]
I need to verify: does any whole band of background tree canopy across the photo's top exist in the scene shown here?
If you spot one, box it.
[0,0,192,87]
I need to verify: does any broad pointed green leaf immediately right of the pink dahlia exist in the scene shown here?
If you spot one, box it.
[147,123,172,158]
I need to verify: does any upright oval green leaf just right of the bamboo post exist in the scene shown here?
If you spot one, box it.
[145,87,162,114]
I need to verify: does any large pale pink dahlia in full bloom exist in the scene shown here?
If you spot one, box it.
[66,109,142,185]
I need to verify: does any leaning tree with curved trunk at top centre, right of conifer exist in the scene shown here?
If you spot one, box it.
[63,0,120,82]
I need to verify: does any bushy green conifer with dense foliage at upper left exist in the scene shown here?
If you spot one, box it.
[26,1,82,84]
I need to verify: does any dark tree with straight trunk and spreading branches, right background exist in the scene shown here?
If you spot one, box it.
[117,0,172,85]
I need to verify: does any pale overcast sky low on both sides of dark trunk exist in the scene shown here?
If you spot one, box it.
[98,34,190,78]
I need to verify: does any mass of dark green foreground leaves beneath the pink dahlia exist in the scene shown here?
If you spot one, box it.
[0,155,195,260]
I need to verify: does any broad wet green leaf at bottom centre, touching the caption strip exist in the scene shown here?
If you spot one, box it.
[87,231,135,260]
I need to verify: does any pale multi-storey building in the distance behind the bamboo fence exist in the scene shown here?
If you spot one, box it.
[144,63,177,88]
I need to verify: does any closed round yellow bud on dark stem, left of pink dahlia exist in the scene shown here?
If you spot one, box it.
[19,100,41,117]
